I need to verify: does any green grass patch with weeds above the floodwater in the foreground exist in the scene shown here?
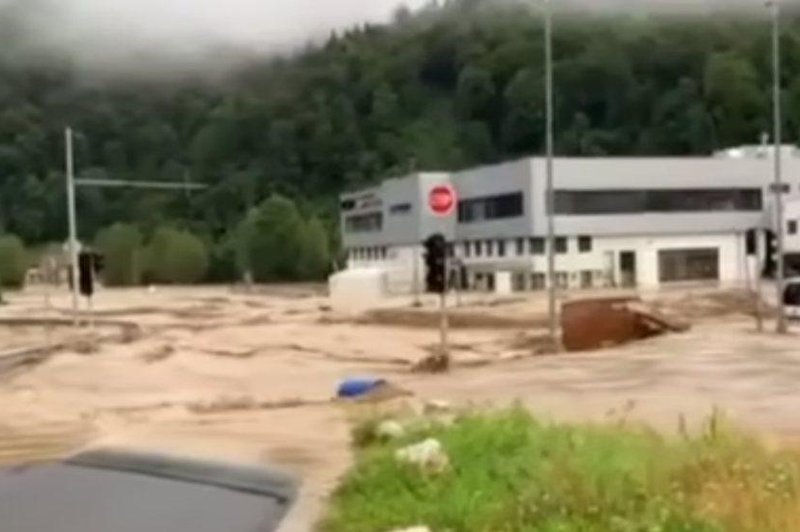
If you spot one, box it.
[320,409,800,532]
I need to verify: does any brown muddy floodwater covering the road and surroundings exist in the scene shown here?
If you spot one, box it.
[0,288,800,528]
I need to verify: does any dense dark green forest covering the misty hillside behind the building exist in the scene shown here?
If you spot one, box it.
[0,0,800,277]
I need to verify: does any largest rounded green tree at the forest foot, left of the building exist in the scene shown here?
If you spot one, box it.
[239,195,305,283]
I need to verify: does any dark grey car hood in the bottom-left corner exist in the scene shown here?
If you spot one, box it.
[0,451,297,532]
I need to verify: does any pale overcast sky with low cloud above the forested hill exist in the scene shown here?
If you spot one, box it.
[0,0,784,78]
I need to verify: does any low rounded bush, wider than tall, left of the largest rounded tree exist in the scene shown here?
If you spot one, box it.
[146,227,209,284]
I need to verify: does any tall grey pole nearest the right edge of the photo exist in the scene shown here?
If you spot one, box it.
[767,0,787,334]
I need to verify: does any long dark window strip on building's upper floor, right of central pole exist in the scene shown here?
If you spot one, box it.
[555,188,763,215]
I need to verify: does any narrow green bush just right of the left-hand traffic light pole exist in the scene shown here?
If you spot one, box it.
[95,223,143,286]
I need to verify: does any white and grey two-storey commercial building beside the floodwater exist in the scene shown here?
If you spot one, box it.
[341,148,800,293]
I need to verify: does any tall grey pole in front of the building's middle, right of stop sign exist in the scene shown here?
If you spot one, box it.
[544,0,559,346]
